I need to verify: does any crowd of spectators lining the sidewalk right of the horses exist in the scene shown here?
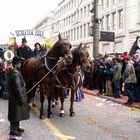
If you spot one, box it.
[83,52,140,104]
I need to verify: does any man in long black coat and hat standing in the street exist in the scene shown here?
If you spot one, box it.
[7,56,29,136]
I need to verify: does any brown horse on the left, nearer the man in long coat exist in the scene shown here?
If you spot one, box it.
[23,34,73,119]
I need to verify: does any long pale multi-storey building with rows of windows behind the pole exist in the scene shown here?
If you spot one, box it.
[34,0,140,56]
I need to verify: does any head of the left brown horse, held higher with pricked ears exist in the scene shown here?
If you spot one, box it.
[57,34,73,64]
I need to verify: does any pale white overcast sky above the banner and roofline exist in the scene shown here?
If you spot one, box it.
[0,0,62,44]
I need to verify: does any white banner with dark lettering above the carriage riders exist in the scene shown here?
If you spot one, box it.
[15,29,44,37]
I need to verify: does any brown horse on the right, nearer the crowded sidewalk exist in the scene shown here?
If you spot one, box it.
[53,43,91,117]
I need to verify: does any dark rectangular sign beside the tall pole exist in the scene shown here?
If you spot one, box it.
[100,31,115,42]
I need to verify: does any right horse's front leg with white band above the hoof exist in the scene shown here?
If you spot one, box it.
[60,88,65,117]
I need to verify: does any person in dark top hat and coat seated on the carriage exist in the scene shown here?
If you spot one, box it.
[17,37,34,60]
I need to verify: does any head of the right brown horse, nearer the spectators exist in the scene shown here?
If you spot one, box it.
[73,43,91,71]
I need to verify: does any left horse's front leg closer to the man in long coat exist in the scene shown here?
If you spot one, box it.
[40,86,45,119]
